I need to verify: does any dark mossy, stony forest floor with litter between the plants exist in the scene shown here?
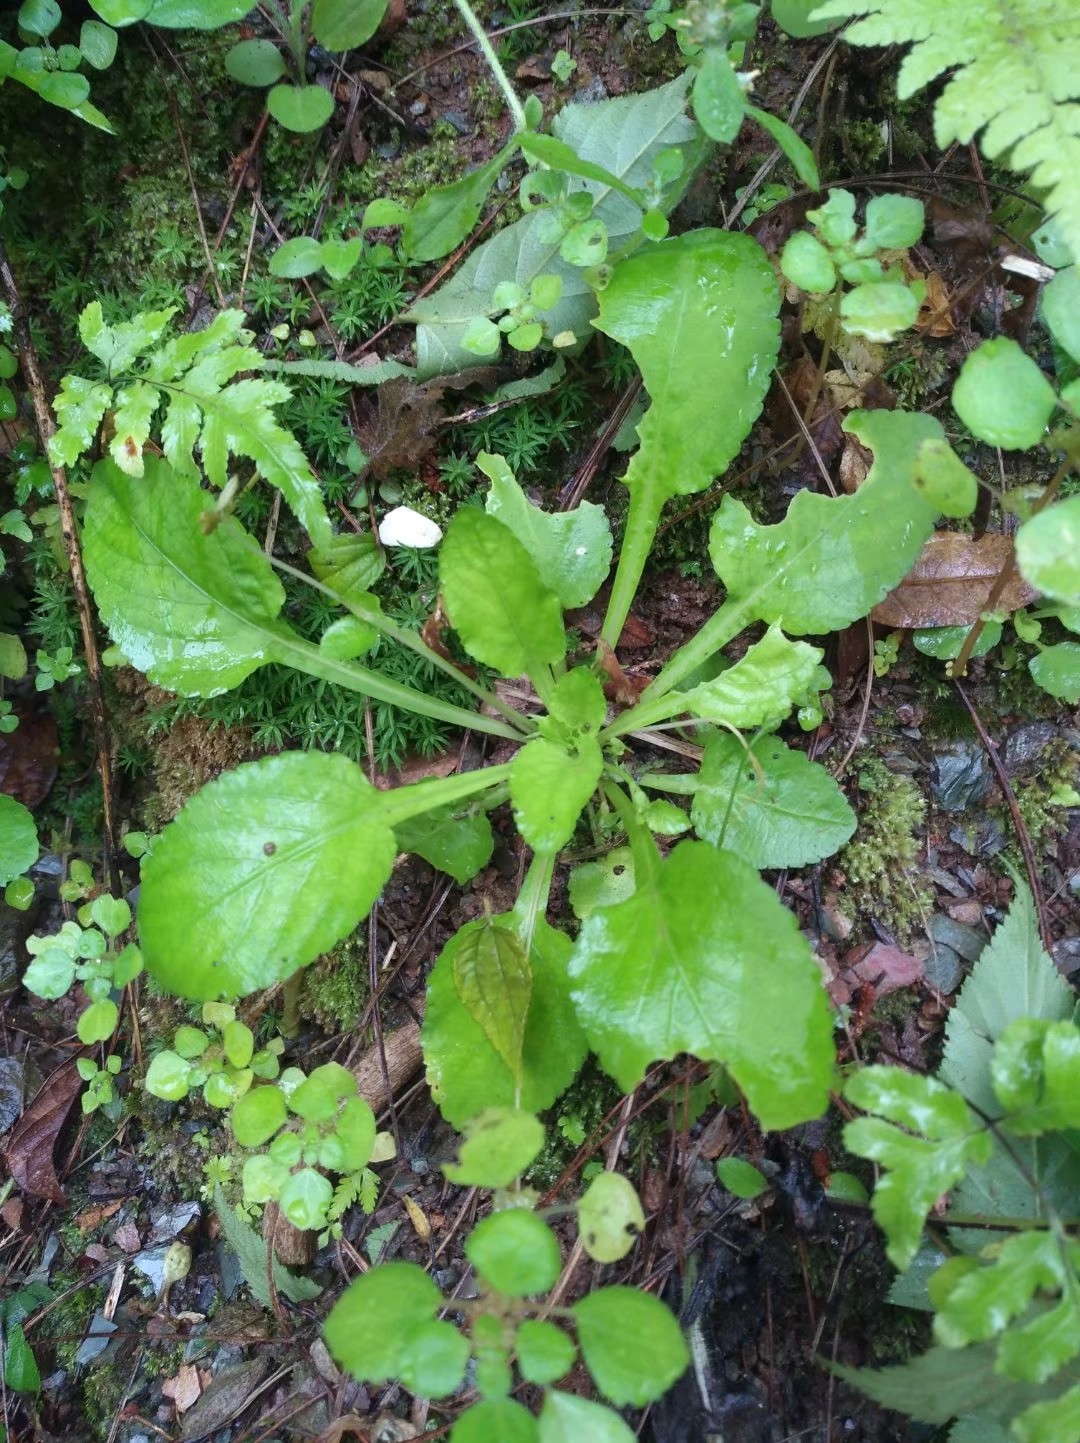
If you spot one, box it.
[0,3,1080,1443]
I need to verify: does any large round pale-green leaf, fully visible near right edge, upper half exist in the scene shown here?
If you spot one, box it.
[953,336,1057,450]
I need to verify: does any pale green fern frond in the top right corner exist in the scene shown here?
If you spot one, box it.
[813,0,1080,260]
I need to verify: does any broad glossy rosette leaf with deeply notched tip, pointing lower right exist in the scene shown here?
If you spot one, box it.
[570,841,833,1128]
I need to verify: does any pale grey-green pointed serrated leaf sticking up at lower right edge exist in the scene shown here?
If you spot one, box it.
[939,883,1076,1118]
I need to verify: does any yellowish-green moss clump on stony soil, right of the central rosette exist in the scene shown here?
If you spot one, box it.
[837,758,931,941]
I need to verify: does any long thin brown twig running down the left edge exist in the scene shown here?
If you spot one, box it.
[0,244,120,893]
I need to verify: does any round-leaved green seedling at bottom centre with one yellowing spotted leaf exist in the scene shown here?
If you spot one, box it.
[325,1108,689,1443]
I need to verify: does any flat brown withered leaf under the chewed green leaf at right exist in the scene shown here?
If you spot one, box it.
[871,531,1038,629]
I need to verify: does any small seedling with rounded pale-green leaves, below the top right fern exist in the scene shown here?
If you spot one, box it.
[780,189,926,341]
